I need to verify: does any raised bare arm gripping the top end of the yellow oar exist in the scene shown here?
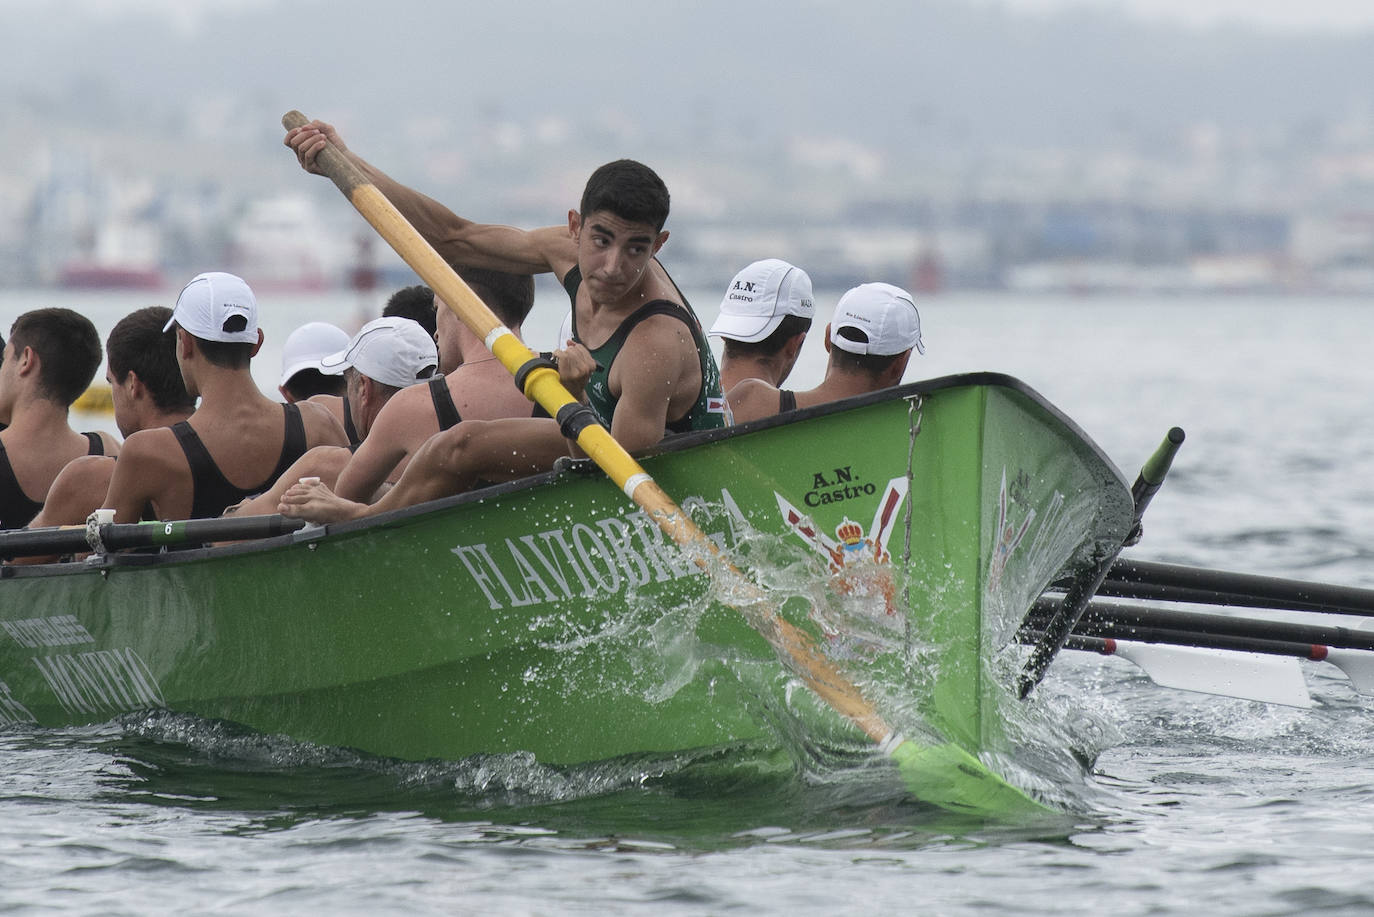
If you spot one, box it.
[284,121,577,278]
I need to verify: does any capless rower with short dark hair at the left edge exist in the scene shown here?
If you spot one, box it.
[0,309,120,528]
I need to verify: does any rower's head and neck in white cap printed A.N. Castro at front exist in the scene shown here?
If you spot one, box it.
[710,258,816,393]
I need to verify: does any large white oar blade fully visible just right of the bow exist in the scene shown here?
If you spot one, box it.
[1116,641,1312,708]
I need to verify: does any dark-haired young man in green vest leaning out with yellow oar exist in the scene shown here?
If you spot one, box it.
[282,121,725,521]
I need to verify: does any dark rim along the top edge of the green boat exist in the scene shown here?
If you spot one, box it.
[0,371,1129,580]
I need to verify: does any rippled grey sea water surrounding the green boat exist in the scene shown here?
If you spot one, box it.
[0,290,1374,916]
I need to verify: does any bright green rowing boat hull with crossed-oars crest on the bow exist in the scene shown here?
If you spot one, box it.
[0,374,1132,814]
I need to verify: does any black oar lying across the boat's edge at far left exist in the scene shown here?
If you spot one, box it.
[0,516,305,558]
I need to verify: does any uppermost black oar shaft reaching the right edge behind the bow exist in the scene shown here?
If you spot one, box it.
[1098,560,1374,616]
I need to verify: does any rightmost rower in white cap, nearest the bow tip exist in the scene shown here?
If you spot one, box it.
[730,283,926,423]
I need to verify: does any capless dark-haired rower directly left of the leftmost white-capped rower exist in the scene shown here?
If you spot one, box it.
[29,305,195,528]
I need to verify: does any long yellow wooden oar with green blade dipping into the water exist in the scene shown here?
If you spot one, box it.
[282,111,1043,813]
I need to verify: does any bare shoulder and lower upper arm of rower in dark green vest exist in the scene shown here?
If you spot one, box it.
[610,316,701,452]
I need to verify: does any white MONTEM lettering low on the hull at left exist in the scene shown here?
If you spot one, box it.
[33,648,166,714]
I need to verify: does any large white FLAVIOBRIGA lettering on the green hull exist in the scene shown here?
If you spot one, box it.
[449,491,739,610]
